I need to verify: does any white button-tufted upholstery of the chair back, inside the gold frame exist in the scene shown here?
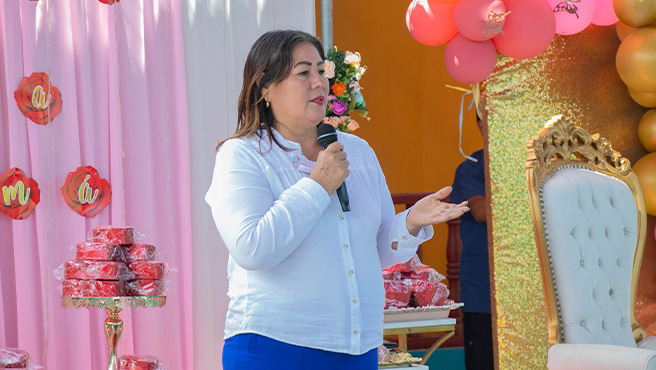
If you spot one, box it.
[540,166,638,347]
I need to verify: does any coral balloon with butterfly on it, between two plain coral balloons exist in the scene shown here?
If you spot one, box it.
[453,0,506,41]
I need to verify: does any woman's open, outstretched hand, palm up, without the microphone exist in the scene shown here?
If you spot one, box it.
[405,186,469,236]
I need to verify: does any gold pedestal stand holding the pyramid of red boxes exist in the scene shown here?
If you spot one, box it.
[61,296,166,370]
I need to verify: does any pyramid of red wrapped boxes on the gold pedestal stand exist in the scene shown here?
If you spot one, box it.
[62,226,169,297]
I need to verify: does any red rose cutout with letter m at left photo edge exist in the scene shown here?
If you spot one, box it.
[0,168,41,220]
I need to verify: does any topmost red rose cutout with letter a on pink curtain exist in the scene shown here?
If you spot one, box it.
[14,72,62,126]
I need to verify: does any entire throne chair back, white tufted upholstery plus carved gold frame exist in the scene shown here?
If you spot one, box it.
[527,117,646,347]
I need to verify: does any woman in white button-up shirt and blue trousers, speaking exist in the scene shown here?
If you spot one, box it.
[205,30,469,370]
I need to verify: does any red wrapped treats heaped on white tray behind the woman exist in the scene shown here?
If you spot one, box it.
[383,255,449,309]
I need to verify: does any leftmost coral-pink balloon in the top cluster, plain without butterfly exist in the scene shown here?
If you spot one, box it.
[405,0,458,46]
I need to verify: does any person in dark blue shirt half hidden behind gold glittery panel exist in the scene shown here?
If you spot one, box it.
[451,115,494,370]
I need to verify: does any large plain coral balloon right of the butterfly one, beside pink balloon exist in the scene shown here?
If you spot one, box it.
[492,0,556,59]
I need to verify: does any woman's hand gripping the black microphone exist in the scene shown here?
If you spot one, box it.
[310,141,350,194]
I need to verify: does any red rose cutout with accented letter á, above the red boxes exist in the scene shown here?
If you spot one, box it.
[61,166,112,217]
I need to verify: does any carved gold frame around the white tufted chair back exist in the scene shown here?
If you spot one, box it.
[526,115,647,345]
